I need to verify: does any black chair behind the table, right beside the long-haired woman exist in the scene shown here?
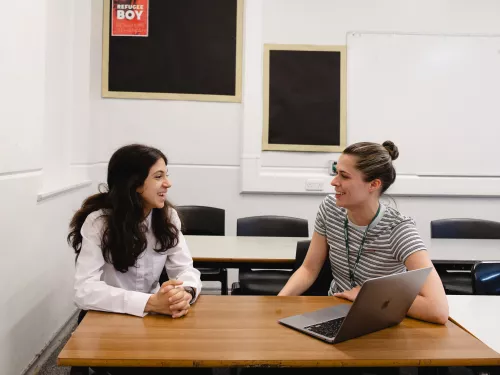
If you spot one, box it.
[160,206,228,295]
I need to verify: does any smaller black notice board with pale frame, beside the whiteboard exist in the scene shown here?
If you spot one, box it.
[263,46,345,151]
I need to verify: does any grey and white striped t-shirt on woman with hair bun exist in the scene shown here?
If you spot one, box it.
[314,195,426,294]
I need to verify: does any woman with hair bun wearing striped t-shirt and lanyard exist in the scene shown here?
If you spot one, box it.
[279,141,448,324]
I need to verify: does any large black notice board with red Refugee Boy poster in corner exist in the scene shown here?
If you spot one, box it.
[103,0,242,101]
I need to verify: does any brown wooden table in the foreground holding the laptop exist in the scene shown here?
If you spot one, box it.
[58,295,500,367]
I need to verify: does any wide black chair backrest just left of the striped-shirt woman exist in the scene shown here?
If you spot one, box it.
[236,215,309,237]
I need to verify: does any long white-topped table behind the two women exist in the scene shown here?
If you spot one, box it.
[186,236,500,269]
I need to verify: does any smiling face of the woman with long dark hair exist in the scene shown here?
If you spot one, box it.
[137,158,172,213]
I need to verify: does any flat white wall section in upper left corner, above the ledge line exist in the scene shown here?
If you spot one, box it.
[0,0,46,174]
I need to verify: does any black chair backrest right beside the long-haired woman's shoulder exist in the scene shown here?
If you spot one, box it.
[176,206,226,236]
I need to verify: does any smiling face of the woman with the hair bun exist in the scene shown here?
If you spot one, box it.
[331,154,381,209]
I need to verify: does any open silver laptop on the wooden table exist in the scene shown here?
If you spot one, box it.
[279,267,432,344]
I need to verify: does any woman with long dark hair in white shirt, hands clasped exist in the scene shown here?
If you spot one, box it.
[68,144,201,318]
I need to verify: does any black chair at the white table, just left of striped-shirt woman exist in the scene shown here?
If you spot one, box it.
[231,215,309,296]
